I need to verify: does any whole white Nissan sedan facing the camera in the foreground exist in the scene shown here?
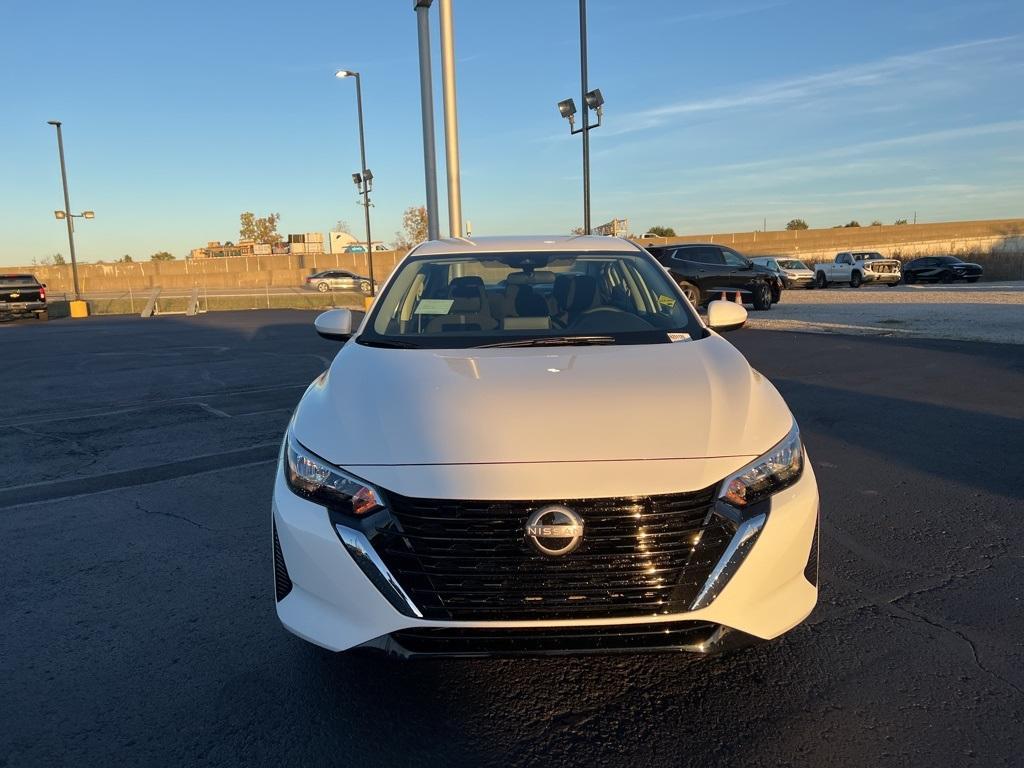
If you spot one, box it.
[272,237,818,656]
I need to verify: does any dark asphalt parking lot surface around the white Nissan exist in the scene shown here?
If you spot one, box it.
[0,311,1024,768]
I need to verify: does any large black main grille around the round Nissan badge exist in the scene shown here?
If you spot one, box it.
[373,488,730,621]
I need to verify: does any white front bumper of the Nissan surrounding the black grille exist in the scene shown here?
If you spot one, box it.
[272,463,818,655]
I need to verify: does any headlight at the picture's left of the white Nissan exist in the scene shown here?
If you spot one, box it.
[284,431,384,516]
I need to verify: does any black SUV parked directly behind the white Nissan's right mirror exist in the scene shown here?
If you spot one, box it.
[647,243,782,309]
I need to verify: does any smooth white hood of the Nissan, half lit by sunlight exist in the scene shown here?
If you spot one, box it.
[293,334,793,467]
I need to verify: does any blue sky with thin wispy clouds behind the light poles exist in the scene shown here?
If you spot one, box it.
[0,0,1024,264]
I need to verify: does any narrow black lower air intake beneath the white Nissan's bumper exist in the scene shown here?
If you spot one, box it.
[391,622,719,656]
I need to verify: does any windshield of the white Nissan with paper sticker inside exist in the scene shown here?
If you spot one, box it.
[357,251,703,348]
